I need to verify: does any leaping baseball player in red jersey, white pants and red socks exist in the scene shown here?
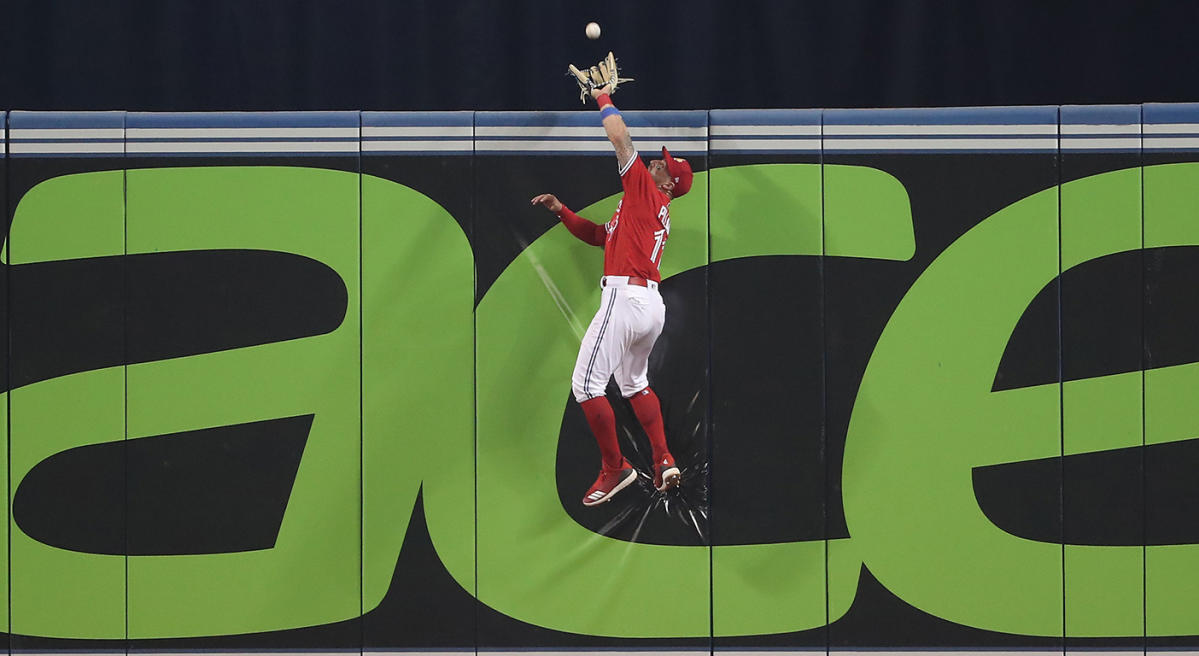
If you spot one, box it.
[531,78,692,506]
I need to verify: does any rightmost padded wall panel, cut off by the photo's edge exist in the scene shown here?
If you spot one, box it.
[1141,104,1199,652]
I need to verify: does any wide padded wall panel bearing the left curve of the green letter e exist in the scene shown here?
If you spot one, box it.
[824,107,1061,651]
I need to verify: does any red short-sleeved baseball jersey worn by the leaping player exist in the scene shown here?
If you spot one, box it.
[603,154,670,282]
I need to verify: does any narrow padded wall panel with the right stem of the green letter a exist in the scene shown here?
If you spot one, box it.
[361,112,477,654]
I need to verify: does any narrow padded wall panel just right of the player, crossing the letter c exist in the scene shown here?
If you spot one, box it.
[709,110,827,652]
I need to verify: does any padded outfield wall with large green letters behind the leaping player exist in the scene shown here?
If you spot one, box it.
[0,104,1199,654]
